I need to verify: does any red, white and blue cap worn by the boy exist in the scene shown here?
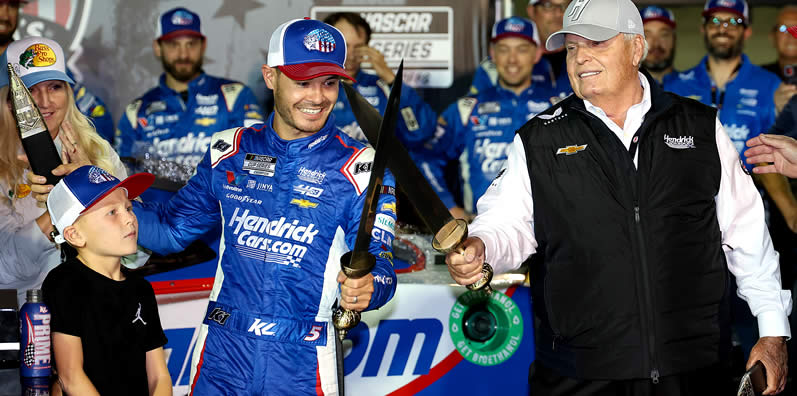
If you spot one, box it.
[47,165,155,243]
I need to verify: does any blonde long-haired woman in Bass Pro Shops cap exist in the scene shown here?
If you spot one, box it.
[0,37,127,305]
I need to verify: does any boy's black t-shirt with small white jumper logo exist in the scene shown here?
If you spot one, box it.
[42,259,166,395]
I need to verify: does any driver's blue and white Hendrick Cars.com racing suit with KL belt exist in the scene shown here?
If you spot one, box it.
[135,113,396,395]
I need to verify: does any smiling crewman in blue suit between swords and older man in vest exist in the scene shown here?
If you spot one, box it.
[414,17,569,217]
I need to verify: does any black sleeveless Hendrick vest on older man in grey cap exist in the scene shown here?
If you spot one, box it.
[518,82,728,379]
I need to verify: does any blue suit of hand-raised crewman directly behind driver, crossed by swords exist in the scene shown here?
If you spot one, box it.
[332,71,437,150]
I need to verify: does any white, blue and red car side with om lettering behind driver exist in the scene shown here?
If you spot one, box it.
[154,283,534,395]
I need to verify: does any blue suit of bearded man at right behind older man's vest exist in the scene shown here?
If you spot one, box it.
[663,55,780,170]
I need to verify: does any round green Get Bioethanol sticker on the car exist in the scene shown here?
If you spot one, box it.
[448,290,523,366]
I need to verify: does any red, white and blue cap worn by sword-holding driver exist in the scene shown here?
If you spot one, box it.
[268,18,354,81]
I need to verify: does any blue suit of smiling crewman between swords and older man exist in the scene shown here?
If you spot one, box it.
[414,84,564,213]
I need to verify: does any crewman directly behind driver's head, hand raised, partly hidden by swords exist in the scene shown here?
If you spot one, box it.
[324,12,437,149]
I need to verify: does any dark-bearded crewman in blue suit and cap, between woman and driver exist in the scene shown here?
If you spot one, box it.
[115,7,263,200]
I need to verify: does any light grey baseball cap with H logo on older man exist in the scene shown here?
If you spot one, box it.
[545,0,645,51]
